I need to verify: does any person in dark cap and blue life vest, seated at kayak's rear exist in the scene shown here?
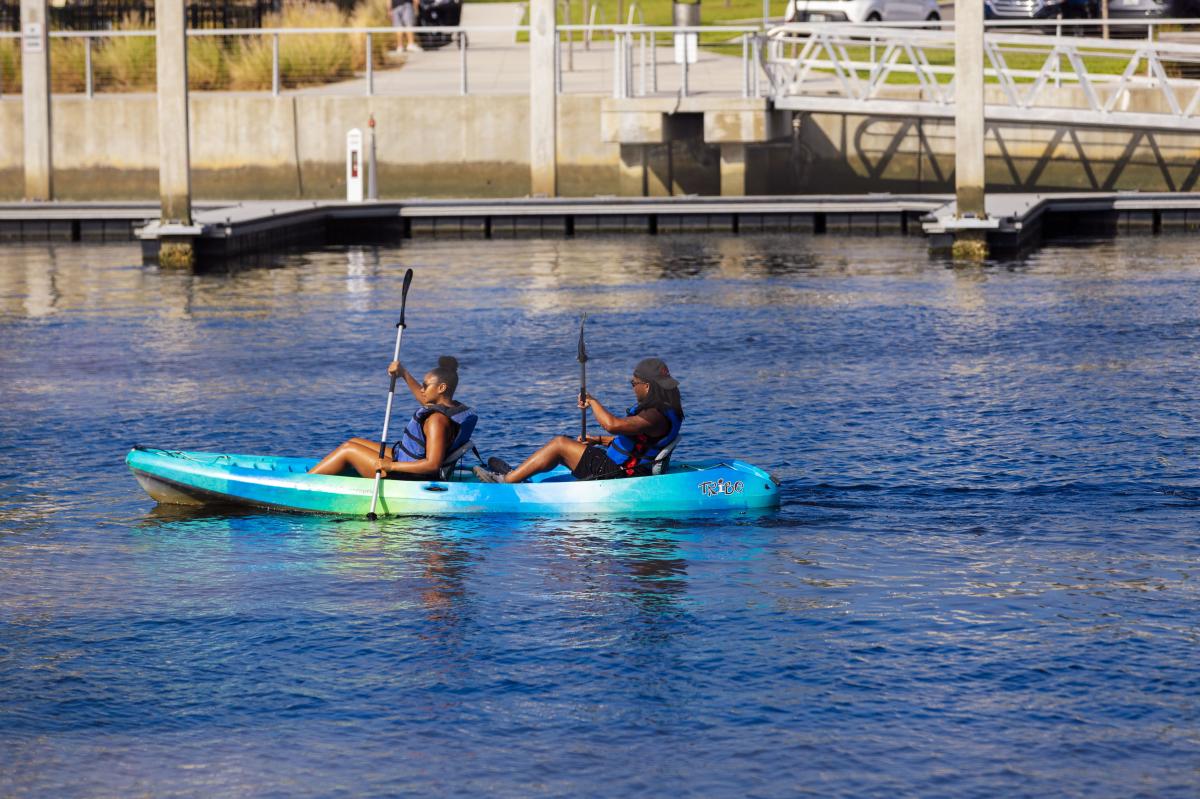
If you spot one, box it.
[475,358,683,482]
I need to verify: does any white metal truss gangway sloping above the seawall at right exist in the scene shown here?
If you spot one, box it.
[763,19,1200,132]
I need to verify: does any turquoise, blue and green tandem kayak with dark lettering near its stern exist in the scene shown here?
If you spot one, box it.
[125,446,779,516]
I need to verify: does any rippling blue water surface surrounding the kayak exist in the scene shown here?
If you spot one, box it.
[0,236,1200,798]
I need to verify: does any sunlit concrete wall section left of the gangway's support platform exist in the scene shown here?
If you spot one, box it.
[0,92,619,199]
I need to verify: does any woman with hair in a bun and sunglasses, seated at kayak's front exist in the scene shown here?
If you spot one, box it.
[308,355,479,480]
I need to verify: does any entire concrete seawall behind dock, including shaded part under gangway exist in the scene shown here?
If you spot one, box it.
[0,90,1200,199]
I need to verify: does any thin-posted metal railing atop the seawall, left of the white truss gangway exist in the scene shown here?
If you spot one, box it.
[0,25,764,97]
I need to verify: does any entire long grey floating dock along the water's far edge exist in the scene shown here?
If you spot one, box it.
[0,192,1200,264]
